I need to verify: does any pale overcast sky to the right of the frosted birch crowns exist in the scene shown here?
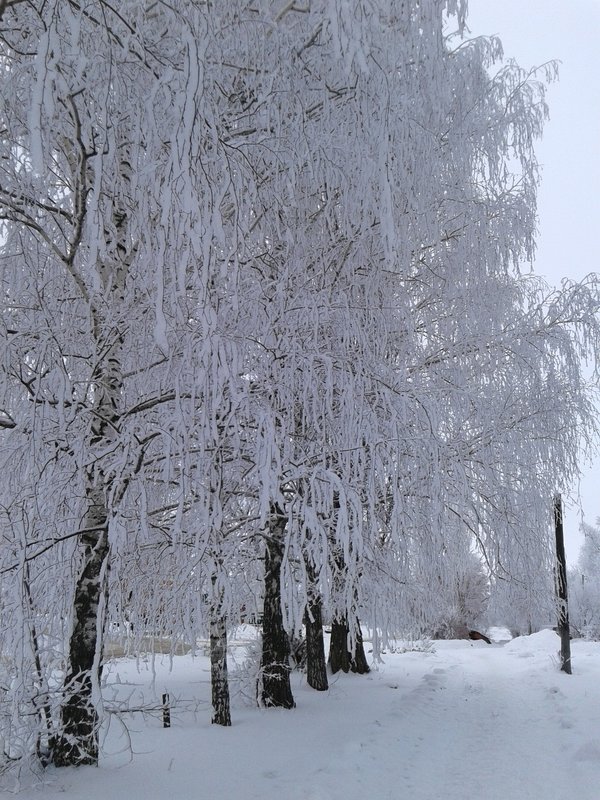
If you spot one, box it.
[468,0,600,564]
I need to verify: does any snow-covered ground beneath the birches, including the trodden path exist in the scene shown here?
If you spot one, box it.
[8,631,600,800]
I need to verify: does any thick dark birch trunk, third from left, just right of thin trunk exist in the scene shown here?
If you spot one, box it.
[260,506,296,708]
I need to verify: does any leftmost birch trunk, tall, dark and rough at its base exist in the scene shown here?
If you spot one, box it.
[53,130,135,766]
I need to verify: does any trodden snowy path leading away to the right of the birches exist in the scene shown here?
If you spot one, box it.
[298,643,600,800]
